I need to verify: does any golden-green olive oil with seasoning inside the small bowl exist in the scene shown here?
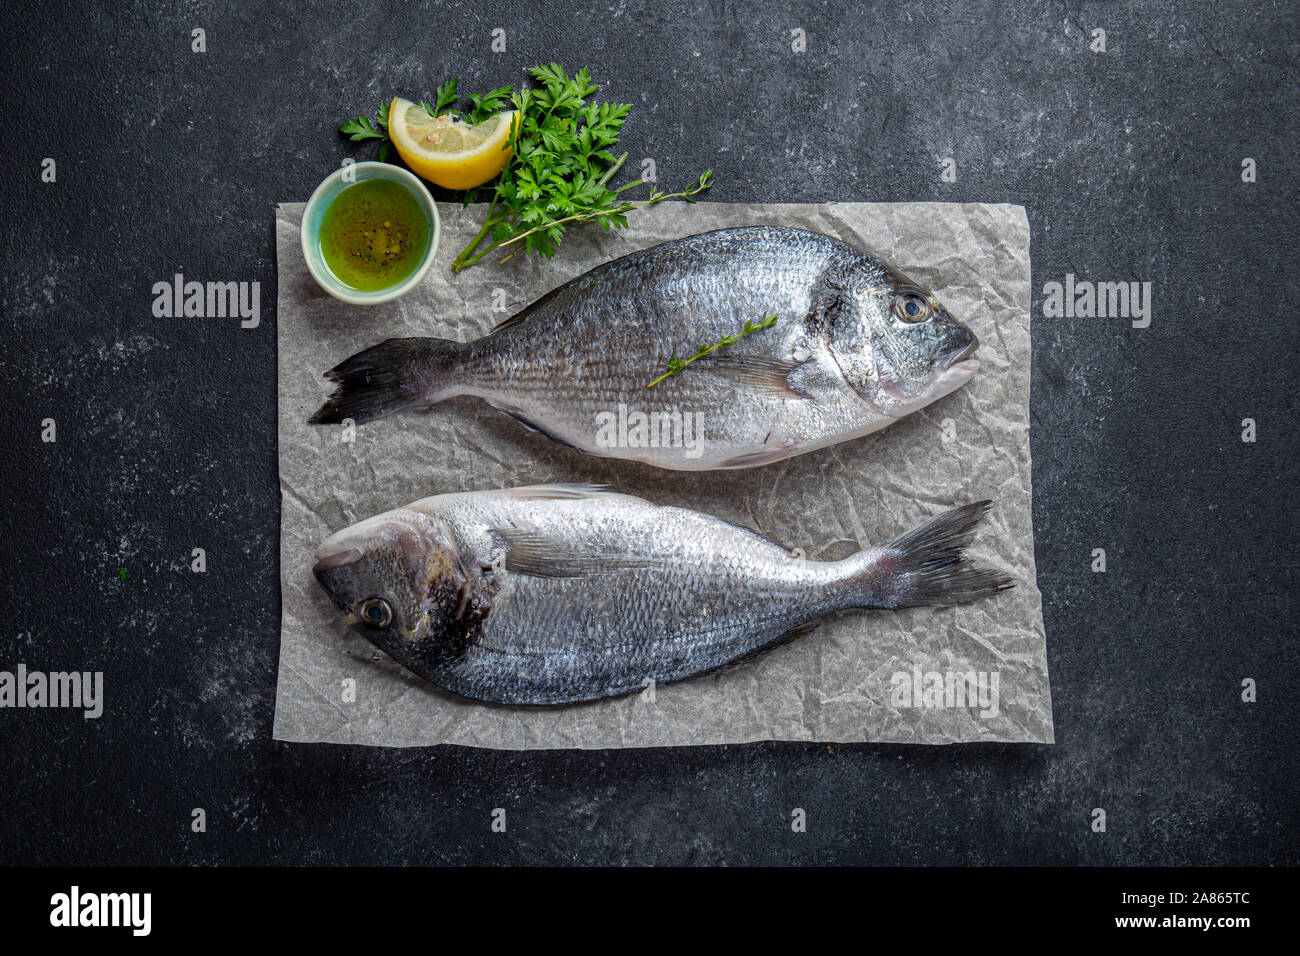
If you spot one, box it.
[320,179,429,291]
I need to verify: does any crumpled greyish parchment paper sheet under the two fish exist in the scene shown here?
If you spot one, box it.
[274,203,1053,749]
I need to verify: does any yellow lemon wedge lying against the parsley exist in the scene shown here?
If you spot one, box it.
[389,96,517,189]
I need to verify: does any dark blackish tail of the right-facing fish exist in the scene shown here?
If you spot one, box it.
[308,338,462,425]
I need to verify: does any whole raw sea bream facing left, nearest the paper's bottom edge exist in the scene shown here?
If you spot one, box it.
[313,485,1011,705]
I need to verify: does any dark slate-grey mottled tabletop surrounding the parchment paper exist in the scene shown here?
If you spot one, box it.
[0,0,1300,864]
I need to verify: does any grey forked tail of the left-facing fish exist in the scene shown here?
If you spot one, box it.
[846,501,1015,607]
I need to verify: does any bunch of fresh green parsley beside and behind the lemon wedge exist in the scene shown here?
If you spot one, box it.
[339,62,717,273]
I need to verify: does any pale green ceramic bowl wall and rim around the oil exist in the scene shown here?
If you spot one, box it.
[302,163,442,306]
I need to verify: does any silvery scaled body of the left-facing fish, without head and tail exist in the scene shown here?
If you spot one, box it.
[411,493,845,704]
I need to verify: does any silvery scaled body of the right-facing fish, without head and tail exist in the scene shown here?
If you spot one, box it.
[441,226,891,470]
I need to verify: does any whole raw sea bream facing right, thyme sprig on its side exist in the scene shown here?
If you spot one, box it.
[311,226,979,471]
